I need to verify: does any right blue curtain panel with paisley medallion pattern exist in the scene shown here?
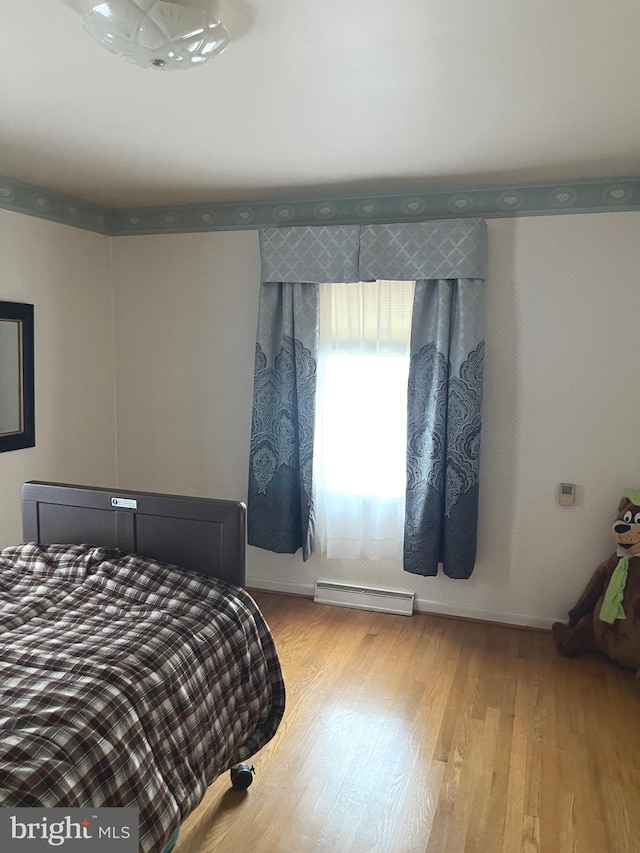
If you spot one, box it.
[404,279,484,578]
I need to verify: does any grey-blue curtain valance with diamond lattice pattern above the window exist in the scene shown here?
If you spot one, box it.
[260,219,486,282]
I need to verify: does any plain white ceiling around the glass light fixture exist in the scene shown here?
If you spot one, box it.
[0,0,640,207]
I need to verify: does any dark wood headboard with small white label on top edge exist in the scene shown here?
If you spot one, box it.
[22,481,246,586]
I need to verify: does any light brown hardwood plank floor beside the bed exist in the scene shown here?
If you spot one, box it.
[175,592,640,853]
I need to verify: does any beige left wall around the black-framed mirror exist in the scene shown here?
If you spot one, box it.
[0,210,115,547]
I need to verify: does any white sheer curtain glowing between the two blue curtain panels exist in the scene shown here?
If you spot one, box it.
[314,281,414,560]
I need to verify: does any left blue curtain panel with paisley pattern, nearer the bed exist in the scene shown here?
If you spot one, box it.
[247,282,318,560]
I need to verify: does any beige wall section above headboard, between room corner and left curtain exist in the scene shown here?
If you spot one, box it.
[113,232,259,500]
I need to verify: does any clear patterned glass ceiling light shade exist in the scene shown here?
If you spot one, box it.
[84,0,229,71]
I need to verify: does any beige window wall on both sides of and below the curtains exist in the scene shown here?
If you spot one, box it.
[113,213,640,626]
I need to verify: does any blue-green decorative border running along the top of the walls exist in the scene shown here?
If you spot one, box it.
[0,172,640,237]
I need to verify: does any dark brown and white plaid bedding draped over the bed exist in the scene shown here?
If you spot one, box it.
[0,544,285,853]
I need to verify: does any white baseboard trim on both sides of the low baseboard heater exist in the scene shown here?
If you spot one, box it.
[246,577,557,631]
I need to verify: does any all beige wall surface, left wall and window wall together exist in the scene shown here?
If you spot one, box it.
[0,211,640,625]
